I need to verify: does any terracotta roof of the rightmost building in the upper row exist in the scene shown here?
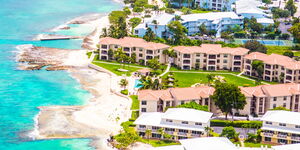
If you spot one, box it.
[245,52,300,70]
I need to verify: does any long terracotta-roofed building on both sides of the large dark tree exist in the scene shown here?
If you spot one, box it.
[138,83,300,116]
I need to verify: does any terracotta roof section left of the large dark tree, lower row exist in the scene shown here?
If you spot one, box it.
[138,86,215,101]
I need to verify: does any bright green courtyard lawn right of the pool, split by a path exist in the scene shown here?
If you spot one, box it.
[169,72,255,87]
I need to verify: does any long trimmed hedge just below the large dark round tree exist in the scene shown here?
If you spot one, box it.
[210,120,262,128]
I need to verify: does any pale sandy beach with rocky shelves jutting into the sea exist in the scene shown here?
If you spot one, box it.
[17,13,135,150]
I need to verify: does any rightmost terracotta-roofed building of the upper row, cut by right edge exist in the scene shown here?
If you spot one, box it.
[244,52,300,83]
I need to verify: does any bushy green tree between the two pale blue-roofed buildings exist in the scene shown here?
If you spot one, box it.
[167,21,188,45]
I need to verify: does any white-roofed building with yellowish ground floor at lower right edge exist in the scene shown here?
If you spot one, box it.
[261,110,300,144]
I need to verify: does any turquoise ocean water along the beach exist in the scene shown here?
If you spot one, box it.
[0,0,121,150]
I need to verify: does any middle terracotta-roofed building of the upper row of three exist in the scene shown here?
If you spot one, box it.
[173,44,249,71]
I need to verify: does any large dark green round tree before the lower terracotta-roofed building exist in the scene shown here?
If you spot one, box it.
[210,82,247,119]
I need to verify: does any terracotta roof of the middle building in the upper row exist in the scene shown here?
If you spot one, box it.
[174,44,249,55]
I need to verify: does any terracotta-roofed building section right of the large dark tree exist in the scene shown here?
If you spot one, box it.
[239,83,300,115]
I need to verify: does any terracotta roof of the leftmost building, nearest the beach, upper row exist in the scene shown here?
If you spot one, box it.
[99,37,170,50]
